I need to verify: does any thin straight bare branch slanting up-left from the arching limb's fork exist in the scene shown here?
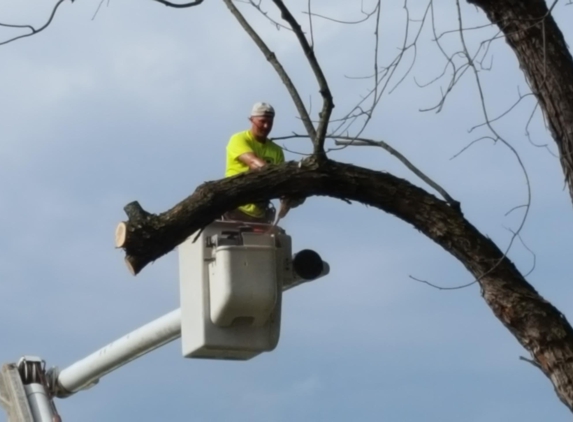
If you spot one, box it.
[223,0,316,139]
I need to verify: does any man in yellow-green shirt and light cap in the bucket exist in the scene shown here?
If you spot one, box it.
[224,102,302,223]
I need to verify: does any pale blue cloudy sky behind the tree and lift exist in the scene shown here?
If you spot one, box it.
[0,0,573,422]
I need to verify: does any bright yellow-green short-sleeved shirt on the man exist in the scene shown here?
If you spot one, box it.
[225,130,285,217]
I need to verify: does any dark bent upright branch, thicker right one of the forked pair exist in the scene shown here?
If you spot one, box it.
[273,0,334,156]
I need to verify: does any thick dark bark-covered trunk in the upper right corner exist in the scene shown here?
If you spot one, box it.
[468,0,573,206]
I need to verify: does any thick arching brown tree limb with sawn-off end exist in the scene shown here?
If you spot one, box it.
[117,160,573,410]
